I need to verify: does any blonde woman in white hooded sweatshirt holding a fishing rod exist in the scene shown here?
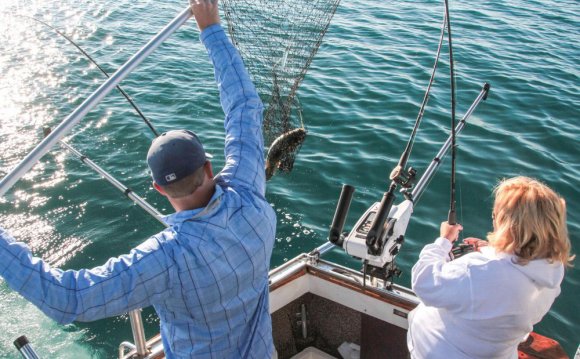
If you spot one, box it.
[407,177,573,359]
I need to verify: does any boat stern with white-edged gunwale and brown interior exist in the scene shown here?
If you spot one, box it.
[123,254,568,359]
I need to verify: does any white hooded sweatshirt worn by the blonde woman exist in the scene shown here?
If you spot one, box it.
[407,238,564,359]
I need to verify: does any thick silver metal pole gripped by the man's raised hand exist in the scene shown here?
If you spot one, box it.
[0,6,192,196]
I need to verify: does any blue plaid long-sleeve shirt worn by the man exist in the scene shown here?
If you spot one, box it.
[0,25,276,359]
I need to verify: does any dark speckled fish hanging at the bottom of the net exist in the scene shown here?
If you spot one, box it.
[266,127,306,181]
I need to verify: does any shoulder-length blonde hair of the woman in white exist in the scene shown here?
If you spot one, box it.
[487,177,574,266]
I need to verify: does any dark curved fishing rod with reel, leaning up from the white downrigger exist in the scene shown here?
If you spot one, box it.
[366,13,448,255]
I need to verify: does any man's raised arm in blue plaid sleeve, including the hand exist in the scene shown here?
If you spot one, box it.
[191,0,266,197]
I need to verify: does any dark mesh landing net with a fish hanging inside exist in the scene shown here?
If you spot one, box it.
[222,0,340,179]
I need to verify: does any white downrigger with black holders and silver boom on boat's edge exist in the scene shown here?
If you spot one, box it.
[326,83,491,289]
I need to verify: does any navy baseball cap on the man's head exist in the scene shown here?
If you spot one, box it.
[147,130,212,186]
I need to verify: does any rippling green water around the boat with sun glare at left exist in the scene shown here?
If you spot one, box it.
[0,0,580,358]
